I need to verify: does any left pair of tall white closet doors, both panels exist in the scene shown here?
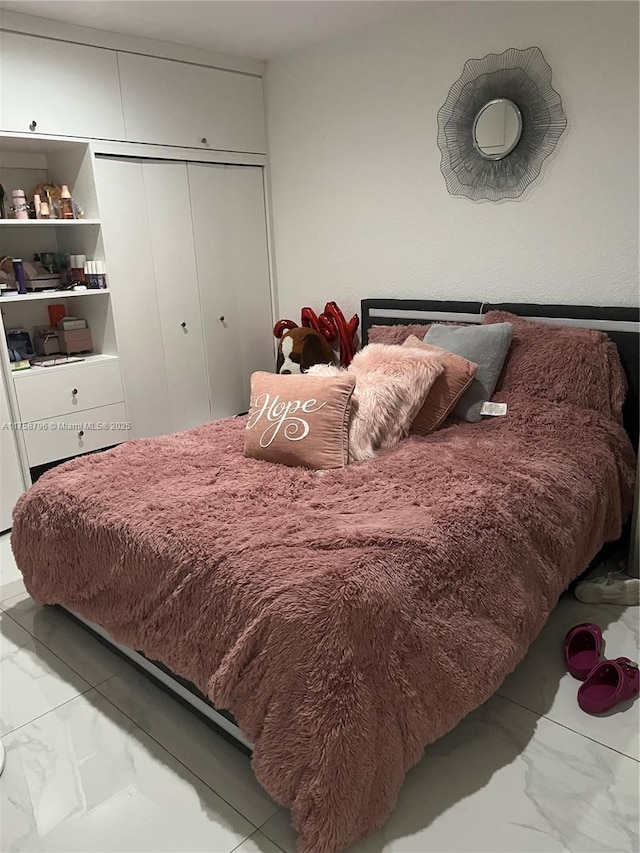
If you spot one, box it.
[96,158,211,438]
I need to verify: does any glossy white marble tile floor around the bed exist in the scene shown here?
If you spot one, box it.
[0,536,640,853]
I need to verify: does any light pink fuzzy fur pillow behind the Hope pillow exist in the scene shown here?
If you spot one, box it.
[308,344,443,462]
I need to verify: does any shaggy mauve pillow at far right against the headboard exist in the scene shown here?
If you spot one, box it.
[483,311,627,421]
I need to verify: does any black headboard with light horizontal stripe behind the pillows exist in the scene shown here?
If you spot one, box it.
[362,299,640,450]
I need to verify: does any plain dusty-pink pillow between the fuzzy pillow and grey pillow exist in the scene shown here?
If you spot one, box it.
[403,335,478,435]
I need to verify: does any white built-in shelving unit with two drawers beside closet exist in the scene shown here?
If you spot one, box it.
[0,134,129,500]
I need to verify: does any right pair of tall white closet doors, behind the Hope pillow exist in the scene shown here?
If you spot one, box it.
[188,164,275,418]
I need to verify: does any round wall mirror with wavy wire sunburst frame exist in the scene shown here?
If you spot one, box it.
[438,47,567,201]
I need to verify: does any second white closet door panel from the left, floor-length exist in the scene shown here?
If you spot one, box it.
[142,161,211,432]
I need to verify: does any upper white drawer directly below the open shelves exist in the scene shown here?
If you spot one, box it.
[14,359,124,421]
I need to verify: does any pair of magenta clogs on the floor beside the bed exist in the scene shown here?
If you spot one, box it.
[564,622,640,714]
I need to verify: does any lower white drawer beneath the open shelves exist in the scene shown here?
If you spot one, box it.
[24,403,129,468]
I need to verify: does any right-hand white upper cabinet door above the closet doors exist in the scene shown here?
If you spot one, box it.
[118,53,266,153]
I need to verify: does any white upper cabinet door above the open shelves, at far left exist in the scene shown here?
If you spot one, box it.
[0,32,125,139]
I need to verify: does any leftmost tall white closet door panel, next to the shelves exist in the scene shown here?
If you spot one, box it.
[95,157,172,438]
